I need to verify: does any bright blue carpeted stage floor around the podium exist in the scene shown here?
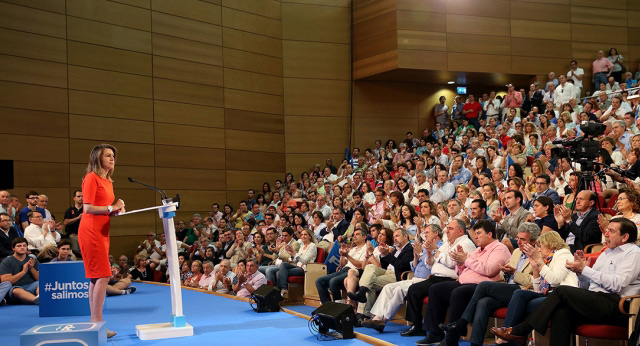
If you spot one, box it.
[0,283,366,346]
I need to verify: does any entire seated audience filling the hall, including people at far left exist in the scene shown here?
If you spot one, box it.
[0,52,640,345]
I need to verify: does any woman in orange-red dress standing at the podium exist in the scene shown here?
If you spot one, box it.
[78,144,125,337]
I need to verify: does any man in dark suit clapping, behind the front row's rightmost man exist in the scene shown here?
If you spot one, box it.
[554,190,602,253]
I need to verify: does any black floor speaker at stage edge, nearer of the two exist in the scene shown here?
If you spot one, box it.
[311,302,356,339]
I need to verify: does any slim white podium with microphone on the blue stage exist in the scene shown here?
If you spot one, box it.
[120,198,193,340]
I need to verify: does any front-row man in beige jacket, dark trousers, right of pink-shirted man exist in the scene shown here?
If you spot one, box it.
[440,222,540,345]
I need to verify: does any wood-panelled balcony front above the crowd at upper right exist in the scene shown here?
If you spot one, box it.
[354,0,640,93]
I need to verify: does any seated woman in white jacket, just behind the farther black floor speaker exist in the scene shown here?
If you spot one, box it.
[276,229,318,298]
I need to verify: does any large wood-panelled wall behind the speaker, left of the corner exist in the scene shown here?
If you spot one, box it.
[0,0,290,254]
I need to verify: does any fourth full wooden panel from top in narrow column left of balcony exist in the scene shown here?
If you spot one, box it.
[285,116,350,153]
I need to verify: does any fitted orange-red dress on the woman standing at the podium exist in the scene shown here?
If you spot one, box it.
[78,172,115,279]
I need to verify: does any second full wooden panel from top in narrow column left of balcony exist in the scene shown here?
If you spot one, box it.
[282,41,351,80]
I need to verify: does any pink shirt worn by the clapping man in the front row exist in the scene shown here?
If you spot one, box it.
[456,240,511,285]
